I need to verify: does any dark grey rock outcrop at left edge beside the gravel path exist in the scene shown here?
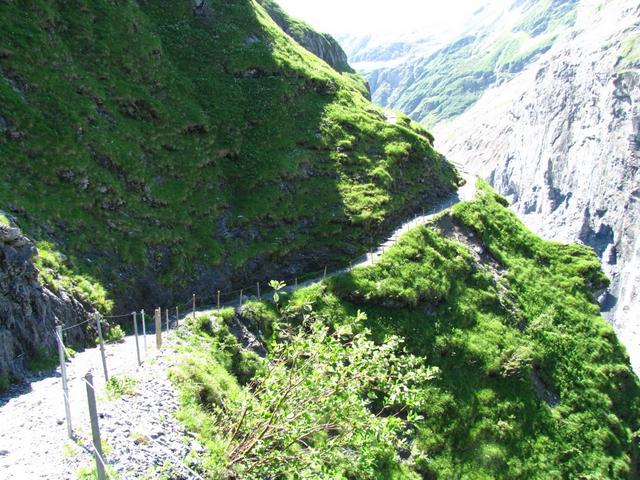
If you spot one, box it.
[0,221,93,380]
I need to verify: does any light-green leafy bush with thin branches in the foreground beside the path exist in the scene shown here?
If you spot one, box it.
[174,314,435,479]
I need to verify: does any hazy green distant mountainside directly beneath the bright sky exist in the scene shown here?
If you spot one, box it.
[339,0,578,124]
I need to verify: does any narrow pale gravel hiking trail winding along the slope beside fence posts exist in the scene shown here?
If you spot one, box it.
[0,172,476,480]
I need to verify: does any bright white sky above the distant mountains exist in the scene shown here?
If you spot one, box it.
[277,0,485,35]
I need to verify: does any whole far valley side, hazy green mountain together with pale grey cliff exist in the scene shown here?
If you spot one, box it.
[345,1,640,371]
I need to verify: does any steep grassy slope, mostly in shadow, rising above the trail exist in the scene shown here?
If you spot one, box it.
[0,0,457,307]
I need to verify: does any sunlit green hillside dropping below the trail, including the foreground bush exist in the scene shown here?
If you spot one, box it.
[174,181,640,479]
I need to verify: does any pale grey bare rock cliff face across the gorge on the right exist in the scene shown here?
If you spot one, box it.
[436,0,640,372]
